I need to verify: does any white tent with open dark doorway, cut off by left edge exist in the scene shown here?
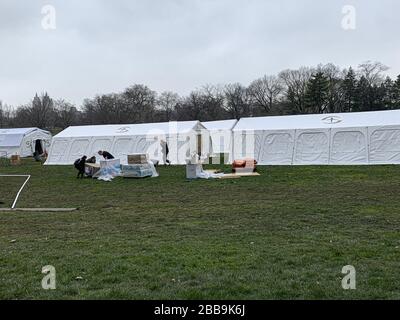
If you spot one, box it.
[0,128,51,158]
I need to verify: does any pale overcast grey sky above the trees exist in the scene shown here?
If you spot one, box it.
[0,0,400,105]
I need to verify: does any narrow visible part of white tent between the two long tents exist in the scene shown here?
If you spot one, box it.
[202,120,238,163]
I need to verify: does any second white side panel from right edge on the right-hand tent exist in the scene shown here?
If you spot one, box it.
[330,128,368,164]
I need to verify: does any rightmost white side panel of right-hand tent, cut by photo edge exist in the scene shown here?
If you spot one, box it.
[369,126,400,164]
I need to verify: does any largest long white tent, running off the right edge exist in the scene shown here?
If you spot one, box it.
[233,110,400,165]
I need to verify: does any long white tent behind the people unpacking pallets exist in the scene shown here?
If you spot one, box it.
[45,121,209,165]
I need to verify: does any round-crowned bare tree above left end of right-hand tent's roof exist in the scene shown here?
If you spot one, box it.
[248,76,283,114]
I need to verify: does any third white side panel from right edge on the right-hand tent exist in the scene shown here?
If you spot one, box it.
[294,129,330,165]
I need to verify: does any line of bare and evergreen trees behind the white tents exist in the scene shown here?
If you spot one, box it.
[0,61,400,130]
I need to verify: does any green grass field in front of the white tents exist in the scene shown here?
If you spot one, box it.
[0,160,400,299]
